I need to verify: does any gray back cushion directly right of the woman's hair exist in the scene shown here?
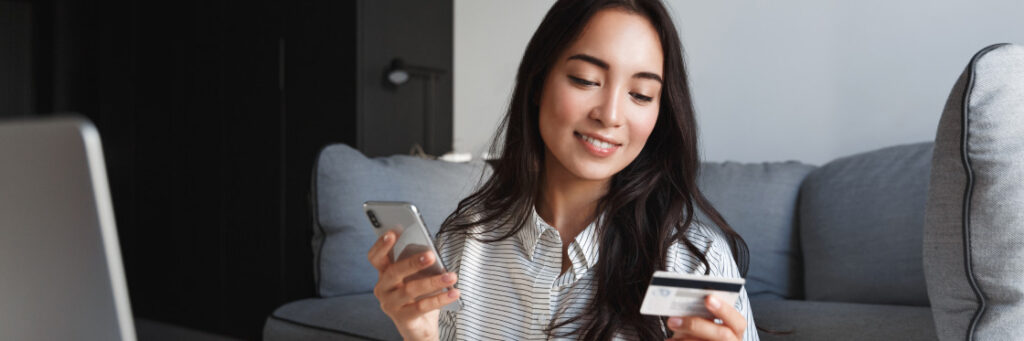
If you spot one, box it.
[698,162,815,299]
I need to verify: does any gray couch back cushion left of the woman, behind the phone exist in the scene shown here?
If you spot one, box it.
[312,144,485,297]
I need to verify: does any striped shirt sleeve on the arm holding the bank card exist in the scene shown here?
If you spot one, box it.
[668,223,760,341]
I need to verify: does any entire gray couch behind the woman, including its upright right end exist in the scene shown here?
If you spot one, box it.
[264,46,1024,340]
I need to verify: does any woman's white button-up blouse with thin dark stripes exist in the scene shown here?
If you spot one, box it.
[437,211,758,341]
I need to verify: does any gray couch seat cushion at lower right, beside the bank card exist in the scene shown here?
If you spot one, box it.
[751,300,935,341]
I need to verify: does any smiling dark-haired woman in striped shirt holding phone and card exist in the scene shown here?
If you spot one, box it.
[368,0,757,340]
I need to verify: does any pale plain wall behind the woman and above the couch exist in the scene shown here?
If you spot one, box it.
[454,0,1024,164]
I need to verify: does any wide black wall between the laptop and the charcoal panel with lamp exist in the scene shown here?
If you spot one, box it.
[24,0,356,339]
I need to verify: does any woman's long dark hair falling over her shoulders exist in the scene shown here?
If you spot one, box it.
[438,0,749,340]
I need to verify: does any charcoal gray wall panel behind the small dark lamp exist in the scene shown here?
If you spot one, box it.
[357,0,453,156]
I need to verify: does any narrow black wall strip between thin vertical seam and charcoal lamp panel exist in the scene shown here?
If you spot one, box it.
[278,0,359,313]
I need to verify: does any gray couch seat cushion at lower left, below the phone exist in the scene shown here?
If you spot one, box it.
[263,294,401,341]
